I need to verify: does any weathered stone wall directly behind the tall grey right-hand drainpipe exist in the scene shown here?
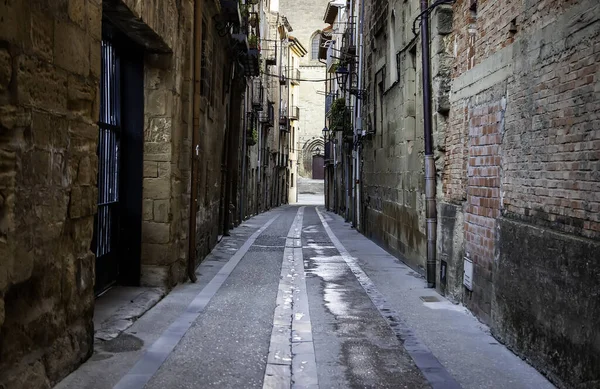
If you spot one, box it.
[362,1,452,268]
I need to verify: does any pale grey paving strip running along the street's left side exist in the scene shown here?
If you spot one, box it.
[114,215,279,389]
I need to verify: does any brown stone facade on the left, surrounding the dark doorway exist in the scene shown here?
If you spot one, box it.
[0,0,283,389]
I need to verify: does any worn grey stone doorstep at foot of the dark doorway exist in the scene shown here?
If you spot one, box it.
[94,286,166,341]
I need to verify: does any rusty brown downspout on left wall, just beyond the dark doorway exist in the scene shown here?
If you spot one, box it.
[187,0,202,282]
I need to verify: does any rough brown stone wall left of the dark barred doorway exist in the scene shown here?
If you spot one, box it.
[0,0,102,389]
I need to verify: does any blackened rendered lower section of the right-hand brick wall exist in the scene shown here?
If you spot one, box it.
[492,218,600,387]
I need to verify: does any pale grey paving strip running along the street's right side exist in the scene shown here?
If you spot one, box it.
[316,208,462,389]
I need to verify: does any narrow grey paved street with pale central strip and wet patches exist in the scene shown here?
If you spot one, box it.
[56,205,553,389]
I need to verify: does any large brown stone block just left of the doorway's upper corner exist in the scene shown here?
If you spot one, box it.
[54,20,90,76]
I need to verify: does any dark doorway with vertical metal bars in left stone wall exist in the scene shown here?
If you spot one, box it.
[92,25,144,294]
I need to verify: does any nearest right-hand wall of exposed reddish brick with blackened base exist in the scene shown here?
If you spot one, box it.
[442,0,600,388]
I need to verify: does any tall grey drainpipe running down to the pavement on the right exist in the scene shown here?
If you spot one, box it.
[421,0,437,288]
